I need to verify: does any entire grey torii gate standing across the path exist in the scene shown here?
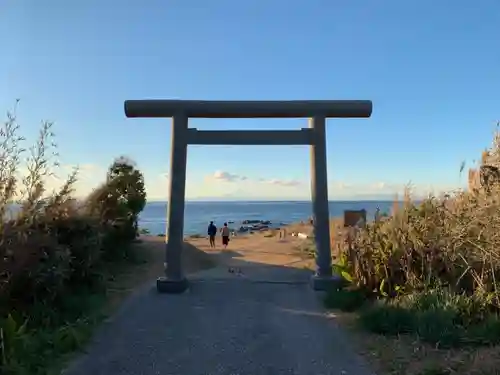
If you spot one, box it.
[125,100,372,293]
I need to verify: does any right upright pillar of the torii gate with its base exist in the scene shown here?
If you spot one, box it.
[309,115,341,291]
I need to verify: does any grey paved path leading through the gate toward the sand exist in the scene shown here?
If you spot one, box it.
[65,234,372,375]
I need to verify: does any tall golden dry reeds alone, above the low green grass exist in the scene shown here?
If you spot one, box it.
[342,185,500,302]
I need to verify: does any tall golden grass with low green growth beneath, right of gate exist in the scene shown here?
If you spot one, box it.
[328,126,500,345]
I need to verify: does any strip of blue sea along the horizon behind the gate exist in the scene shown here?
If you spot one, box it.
[139,201,394,235]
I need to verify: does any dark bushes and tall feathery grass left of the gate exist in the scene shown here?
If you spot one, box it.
[0,106,145,374]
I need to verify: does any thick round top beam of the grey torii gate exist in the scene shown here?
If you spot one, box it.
[125,100,372,118]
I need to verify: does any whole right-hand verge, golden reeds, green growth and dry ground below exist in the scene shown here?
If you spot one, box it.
[322,129,500,375]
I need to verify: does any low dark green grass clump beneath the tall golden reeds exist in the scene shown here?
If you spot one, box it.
[359,289,500,347]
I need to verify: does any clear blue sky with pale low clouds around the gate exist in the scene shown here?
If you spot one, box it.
[0,0,500,199]
